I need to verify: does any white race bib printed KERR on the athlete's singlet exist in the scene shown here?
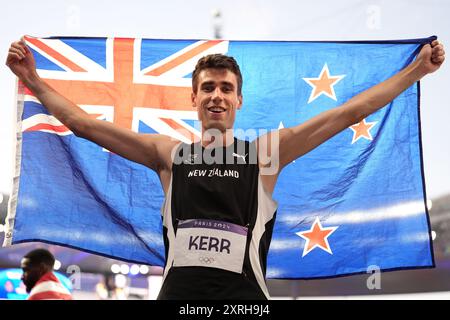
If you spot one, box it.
[173,219,248,273]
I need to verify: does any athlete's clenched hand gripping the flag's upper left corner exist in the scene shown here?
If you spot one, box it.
[6,37,38,82]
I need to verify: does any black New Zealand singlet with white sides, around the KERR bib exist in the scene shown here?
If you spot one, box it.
[158,138,277,299]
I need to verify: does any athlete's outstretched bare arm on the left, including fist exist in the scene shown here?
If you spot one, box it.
[6,39,177,172]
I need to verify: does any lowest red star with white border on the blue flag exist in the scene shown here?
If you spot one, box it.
[295,217,338,258]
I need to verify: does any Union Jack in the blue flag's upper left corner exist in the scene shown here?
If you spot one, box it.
[22,37,228,142]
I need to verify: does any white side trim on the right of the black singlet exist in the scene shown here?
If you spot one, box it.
[248,174,278,299]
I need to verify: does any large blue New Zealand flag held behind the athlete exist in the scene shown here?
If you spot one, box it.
[1,37,435,279]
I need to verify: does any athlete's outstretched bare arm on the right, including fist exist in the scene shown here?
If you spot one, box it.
[279,40,445,170]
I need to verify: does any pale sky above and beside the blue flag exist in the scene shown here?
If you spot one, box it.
[0,0,450,198]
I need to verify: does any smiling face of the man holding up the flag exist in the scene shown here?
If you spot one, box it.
[192,69,242,132]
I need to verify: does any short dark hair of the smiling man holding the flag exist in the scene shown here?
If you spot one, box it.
[192,53,243,95]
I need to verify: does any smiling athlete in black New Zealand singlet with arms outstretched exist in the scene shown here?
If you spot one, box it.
[6,39,445,299]
